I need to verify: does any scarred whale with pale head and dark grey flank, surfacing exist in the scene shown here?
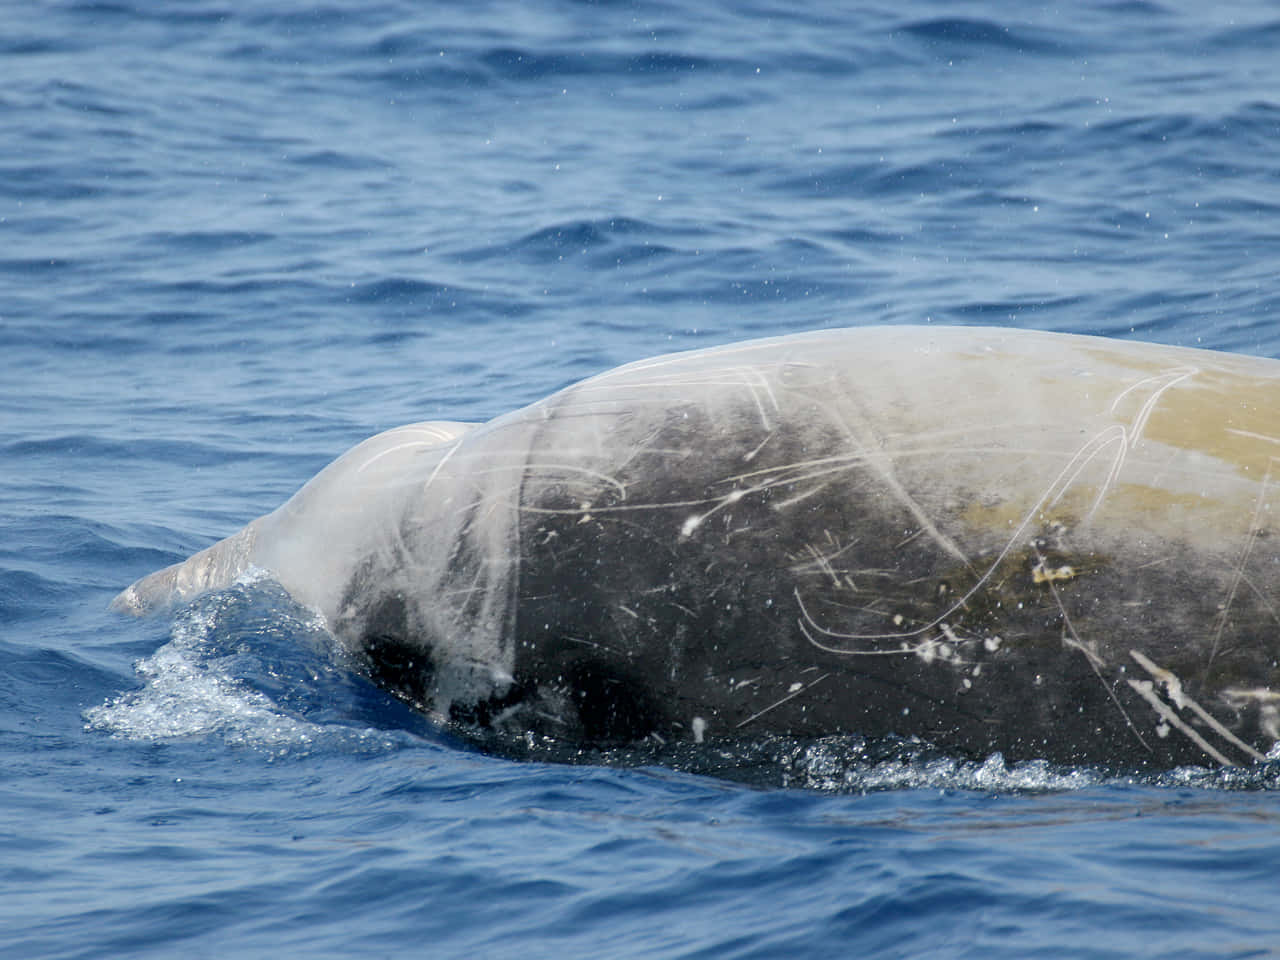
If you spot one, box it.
[116,328,1280,768]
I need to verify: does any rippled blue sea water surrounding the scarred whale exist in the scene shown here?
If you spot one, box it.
[0,0,1280,959]
